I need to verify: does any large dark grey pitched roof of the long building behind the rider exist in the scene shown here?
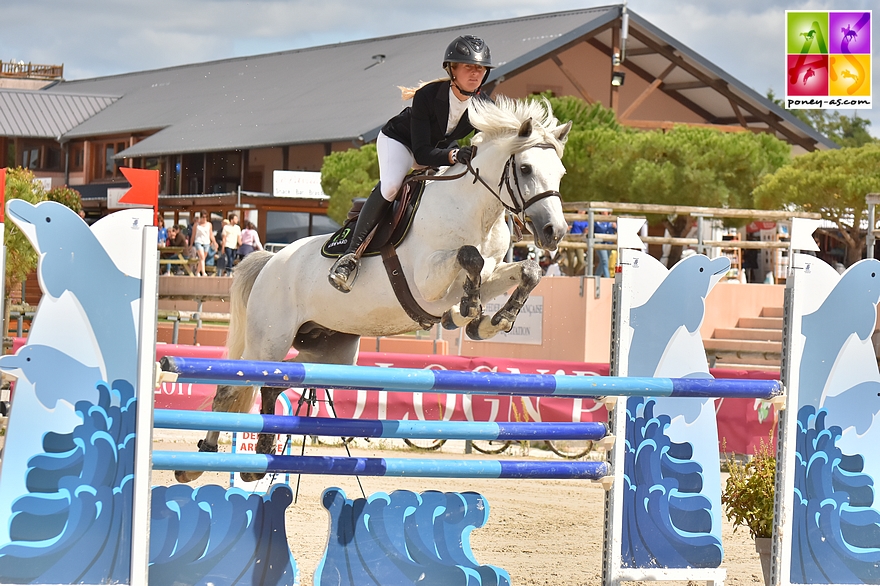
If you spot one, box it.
[34,6,835,157]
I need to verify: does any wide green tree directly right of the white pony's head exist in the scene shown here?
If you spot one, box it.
[562,125,790,266]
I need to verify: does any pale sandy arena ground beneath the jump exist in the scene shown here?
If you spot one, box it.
[153,430,763,586]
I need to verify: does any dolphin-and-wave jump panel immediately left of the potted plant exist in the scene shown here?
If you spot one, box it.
[615,245,730,569]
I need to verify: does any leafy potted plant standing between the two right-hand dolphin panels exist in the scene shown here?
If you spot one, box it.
[721,433,776,584]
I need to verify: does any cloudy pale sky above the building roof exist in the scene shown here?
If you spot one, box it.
[0,0,880,137]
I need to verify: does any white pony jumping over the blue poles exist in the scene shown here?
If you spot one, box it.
[176,97,571,482]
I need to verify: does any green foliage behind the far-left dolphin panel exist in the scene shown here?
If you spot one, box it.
[3,167,46,298]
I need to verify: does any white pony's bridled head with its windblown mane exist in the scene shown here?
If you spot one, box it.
[468,96,571,250]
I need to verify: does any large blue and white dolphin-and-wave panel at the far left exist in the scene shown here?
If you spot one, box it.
[0,200,152,584]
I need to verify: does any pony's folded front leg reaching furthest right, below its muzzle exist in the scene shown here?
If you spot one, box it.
[465,259,542,340]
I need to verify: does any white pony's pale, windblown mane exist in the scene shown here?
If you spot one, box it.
[468,96,565,157]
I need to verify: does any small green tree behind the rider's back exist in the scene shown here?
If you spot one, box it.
[321,144,379,224]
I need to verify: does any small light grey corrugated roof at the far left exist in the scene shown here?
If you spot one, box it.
[0,90,118,140]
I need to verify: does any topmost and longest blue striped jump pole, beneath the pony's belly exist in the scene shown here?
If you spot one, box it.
[161,356,783,399]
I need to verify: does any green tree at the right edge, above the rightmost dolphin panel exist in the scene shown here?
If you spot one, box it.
[755,143,880,266]
